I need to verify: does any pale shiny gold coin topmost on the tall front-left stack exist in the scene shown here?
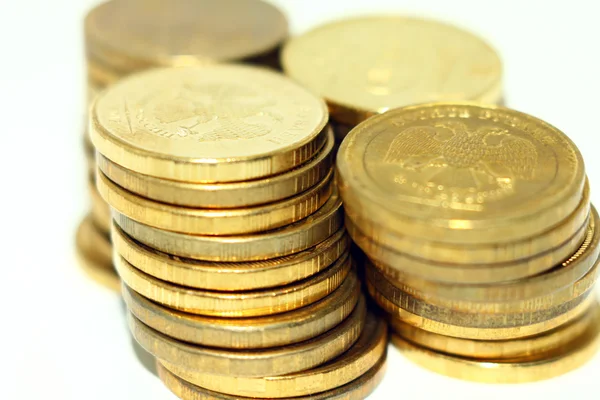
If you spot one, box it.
[90,65,328,183]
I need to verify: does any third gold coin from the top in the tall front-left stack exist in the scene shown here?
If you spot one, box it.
[96,170,333,235]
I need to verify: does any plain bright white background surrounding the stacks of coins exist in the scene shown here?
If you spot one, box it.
[0,0,600,400]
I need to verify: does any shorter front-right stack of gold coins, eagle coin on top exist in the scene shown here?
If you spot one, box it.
[337,104,600,383]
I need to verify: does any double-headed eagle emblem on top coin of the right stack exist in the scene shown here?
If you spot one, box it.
[384,121,538,189]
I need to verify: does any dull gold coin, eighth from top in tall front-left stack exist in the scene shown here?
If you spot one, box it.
[129,299,366,378]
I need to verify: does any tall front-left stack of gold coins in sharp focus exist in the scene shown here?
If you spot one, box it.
[90,65,387,399]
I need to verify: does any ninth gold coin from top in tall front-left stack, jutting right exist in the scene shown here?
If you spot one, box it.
[163,313,388,398]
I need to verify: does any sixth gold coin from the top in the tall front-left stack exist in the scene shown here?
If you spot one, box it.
[114,254,352,317]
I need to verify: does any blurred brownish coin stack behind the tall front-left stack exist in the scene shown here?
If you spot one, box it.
[77,0,288,287]
